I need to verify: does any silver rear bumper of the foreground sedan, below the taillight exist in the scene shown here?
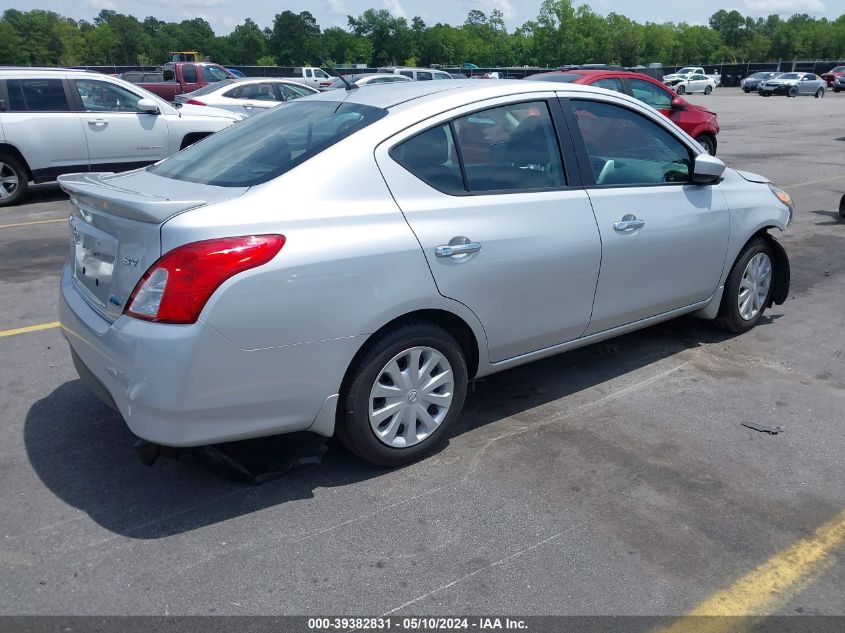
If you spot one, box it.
[59,268,360,446]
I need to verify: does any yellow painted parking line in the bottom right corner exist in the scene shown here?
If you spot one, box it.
[660,511,845,633]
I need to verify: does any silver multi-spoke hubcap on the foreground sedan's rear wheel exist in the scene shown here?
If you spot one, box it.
[369,347,455,448]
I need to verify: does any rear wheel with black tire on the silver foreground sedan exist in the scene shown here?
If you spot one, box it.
[335,321,467,467]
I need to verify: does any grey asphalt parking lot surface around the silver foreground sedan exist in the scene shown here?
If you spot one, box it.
[0,88,845,615]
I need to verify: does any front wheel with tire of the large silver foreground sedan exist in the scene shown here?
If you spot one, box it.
[716,237,775,334]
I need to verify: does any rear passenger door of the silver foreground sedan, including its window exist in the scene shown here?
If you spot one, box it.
[376,93,601,362]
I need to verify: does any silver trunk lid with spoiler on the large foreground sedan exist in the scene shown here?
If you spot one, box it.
[59,170,246,321]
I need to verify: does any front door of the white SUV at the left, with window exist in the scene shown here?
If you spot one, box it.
[70,78,170,171]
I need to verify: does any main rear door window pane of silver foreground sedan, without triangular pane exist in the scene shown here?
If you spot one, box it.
[454,101,564,192]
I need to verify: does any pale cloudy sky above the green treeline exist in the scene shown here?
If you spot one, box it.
[0,0,845,35]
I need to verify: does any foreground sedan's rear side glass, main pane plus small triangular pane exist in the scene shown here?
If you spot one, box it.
[390,101,565,194]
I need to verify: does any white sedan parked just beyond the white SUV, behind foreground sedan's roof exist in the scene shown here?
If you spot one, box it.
[176,77,317,118]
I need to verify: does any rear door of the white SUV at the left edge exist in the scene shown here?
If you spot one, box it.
[0,77,88,181]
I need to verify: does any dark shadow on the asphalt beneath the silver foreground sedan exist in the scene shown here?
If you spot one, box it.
[24,316,760,539]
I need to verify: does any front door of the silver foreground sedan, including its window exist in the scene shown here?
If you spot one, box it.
[568,97,729,334]
